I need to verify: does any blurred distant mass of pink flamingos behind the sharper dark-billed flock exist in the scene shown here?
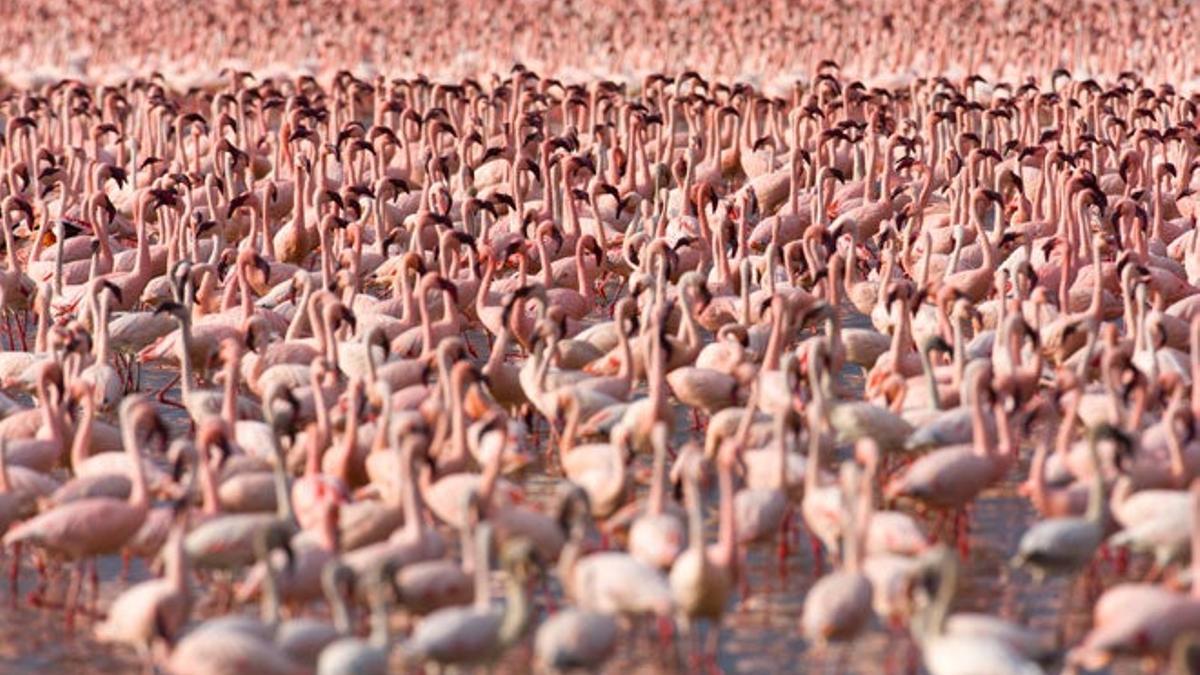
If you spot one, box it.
[7,0,1200,89]
